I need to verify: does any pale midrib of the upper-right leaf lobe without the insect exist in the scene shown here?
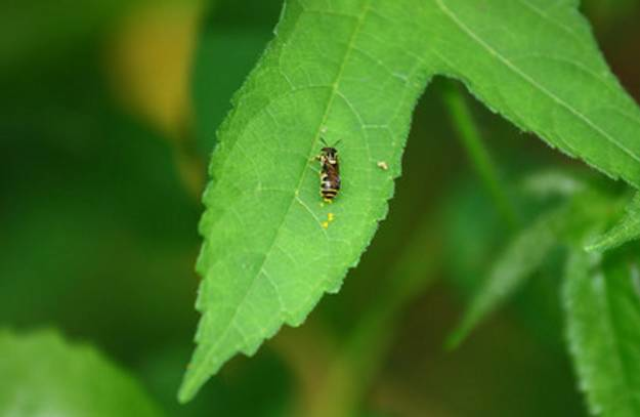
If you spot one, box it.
[435,0,640,171]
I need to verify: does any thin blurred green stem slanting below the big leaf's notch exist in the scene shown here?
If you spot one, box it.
[444,84,518,229]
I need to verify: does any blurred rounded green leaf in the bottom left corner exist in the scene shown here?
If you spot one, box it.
[0,331,161,417]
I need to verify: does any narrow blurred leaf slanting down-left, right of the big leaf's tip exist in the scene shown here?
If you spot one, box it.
[447,207,571,348]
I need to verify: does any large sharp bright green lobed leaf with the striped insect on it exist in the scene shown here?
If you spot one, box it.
[179,0,640,401]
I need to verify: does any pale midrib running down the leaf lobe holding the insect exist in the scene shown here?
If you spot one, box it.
[184,0,372,393]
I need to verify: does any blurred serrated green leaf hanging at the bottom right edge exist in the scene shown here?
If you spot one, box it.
[563,250,640,417]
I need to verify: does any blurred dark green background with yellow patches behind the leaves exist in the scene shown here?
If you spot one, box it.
[0,0,640,417]
